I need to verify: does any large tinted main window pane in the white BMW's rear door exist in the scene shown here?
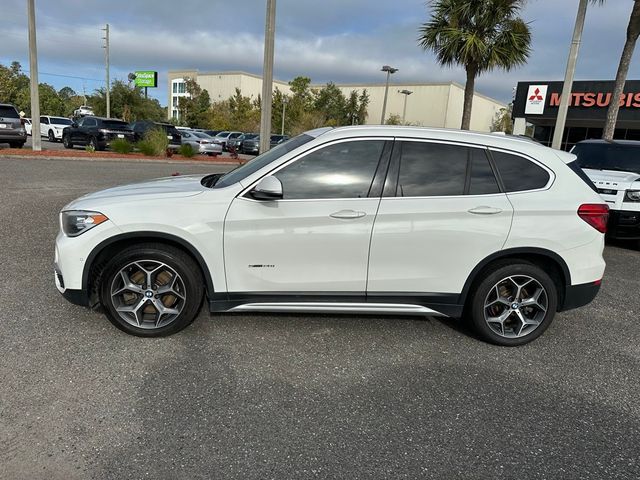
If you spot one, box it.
[396,142,468,197]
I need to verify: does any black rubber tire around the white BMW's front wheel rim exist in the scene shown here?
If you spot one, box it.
[98,243,204,337]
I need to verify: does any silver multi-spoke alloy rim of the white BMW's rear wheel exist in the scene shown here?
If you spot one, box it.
[484,275,549,338]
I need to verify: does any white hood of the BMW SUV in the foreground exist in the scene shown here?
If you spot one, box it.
[63,175,206,210]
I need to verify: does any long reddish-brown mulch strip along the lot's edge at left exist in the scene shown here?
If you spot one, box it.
[0,148,247,164]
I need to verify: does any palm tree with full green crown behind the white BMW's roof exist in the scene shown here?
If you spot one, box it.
[418,0,531,130]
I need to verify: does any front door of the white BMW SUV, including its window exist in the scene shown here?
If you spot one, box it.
[224,138,391,298]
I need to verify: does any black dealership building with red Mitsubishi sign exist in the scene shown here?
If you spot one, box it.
[513,80,640,150]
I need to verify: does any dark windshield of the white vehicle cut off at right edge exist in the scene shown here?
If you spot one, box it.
[571,143,640,174]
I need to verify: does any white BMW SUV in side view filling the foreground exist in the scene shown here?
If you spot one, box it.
[55,126,608,345]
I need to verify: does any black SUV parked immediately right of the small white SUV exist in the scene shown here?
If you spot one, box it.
[62,116,135,150]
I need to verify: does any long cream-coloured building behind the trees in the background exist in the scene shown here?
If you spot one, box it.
[168,70,505,131]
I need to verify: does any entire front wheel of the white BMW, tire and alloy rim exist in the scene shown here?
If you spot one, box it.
[100,243,204,337]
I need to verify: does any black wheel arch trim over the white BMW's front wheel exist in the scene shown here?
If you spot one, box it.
[82,231,215,305]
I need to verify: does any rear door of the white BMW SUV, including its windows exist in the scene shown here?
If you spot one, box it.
[367,140,513,297]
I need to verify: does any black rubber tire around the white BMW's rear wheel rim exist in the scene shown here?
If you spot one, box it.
[466,259,558,347]
